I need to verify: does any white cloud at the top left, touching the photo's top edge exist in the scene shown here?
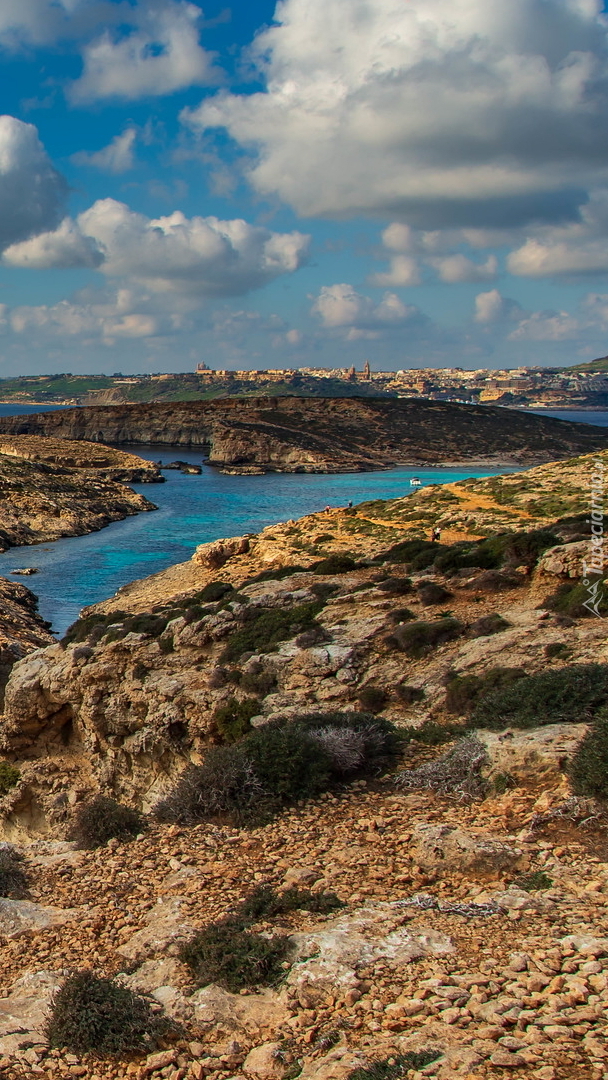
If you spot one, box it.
[68,0,217,104]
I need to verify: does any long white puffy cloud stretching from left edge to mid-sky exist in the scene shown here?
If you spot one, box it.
[4,199,309,297]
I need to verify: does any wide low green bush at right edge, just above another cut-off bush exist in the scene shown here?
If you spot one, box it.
[471,664,608,731]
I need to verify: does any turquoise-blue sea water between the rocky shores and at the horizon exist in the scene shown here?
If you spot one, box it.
[0,405,608,635]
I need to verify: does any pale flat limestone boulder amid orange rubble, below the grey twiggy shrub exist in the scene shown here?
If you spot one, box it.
[410,824,522,873]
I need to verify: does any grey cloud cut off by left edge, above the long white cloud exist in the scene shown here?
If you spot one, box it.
[0,116,67,248]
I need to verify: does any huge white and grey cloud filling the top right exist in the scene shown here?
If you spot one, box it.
[183,0,608,229]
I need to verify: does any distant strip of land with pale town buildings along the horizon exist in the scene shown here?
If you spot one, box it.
[0,357,608,409]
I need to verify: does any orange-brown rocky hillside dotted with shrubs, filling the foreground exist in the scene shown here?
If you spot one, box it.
[0,450,608,1080]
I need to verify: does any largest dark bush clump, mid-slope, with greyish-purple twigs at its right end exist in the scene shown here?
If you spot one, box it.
[154,713,401,824]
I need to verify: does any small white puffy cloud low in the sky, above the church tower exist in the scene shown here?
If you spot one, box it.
[311,283,419,330]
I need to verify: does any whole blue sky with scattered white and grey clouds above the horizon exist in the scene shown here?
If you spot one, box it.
[0,0,608,378]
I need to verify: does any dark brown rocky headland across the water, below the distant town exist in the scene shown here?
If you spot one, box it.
[0,397,608,473]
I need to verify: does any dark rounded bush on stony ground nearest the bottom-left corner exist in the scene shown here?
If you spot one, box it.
[44,971,173,1056]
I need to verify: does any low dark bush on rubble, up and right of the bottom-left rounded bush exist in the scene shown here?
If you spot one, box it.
[179,919,289,994]
